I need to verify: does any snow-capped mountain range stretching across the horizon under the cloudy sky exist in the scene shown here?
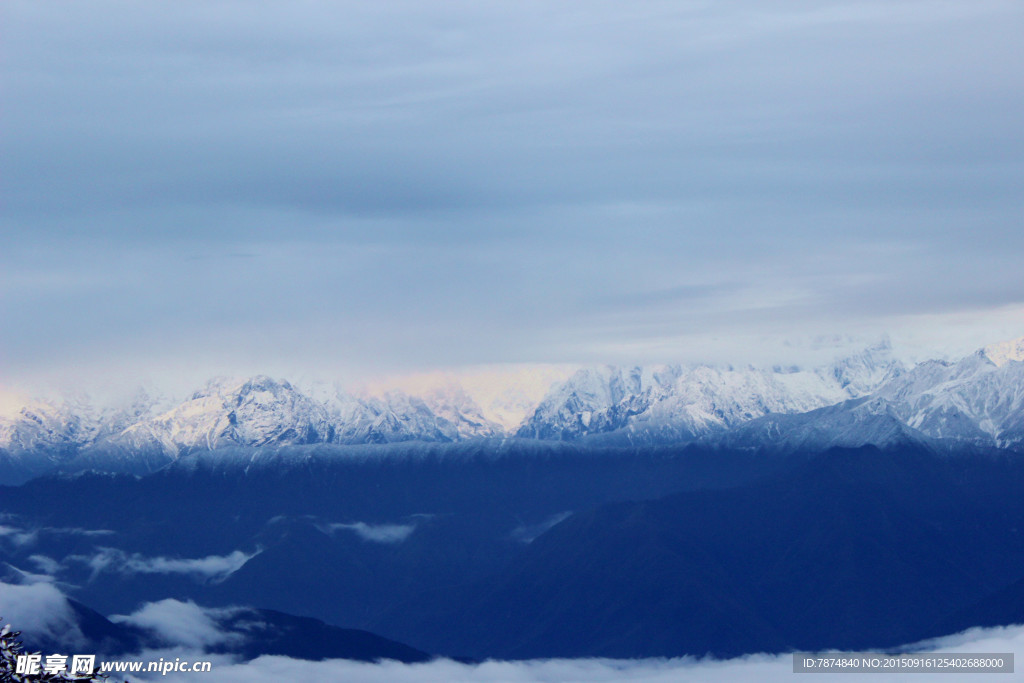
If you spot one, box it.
[0,338,1024,478]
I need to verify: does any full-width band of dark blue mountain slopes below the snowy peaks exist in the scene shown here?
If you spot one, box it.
[0,441,1024,657]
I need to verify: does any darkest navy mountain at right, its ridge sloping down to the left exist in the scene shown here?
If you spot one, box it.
[403,447,1024,657]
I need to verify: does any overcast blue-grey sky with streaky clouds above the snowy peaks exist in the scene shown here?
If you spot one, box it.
[0,0,1024,395]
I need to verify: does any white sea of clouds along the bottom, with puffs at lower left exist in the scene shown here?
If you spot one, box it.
[0,582,1024,683]
